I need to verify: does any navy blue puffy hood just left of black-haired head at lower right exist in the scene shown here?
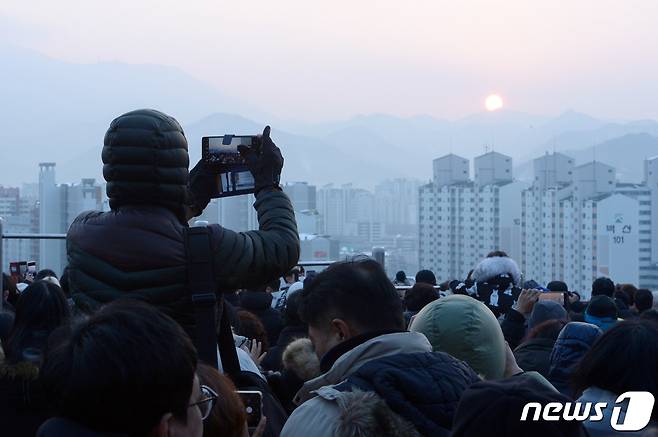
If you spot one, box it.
[548,322,603,397]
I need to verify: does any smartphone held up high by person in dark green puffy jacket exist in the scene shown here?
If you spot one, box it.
[201,135,261,198]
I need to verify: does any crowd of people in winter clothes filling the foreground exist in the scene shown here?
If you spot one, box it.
[0,110,658,437]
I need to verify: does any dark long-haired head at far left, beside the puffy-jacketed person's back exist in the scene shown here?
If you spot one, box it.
[5,281,71,363]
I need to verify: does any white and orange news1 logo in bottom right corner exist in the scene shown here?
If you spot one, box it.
[521,391,655,431]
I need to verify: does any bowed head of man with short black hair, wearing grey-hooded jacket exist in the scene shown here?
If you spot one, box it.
[299,259,405,357]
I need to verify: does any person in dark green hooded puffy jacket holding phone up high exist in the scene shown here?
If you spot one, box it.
[67,110,299,332]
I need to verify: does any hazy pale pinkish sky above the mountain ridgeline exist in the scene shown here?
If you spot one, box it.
[0,0,658,120]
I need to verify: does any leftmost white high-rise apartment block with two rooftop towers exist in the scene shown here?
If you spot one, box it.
[419,152,525,280]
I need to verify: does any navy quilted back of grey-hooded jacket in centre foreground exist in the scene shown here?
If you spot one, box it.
[336,352,480,435]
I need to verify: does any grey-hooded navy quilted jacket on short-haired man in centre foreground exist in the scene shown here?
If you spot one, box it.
[281,332,479,437]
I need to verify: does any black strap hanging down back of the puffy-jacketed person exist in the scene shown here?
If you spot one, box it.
[185,226,240,375]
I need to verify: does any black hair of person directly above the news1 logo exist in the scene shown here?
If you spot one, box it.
[572,319,658,420]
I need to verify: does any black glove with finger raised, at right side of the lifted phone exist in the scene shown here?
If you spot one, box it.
[238,126,283,194]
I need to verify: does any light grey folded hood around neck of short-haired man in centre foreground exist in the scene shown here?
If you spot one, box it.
[295,332,432,405]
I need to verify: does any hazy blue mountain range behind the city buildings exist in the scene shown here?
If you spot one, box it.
[0,47,658,187]
